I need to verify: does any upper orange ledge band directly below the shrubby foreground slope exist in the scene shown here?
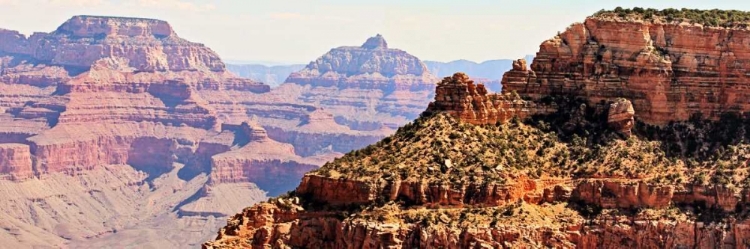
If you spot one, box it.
[296,175,750,212]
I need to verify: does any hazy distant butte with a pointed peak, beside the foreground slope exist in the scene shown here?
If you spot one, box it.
[198,36,438,160]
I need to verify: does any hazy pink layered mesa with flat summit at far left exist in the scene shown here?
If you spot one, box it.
[0,16,276,180]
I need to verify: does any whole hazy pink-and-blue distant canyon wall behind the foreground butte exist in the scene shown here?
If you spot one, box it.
[0,16,437,247]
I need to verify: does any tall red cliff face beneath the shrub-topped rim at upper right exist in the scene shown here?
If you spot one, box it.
[502,15,750,124]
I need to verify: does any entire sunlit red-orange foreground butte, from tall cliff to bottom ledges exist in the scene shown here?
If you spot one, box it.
[203,9,750,248]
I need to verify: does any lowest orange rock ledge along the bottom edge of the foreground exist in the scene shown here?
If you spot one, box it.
[204,200,748,248]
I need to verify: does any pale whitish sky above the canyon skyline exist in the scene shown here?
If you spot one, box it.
[0,0,750,64]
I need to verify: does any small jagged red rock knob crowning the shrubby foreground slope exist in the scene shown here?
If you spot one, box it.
[427,73,557,124]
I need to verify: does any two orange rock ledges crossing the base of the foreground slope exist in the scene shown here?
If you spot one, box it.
[203,176,750,248]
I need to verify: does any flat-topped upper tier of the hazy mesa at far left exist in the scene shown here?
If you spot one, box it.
[2,16,225,72]
